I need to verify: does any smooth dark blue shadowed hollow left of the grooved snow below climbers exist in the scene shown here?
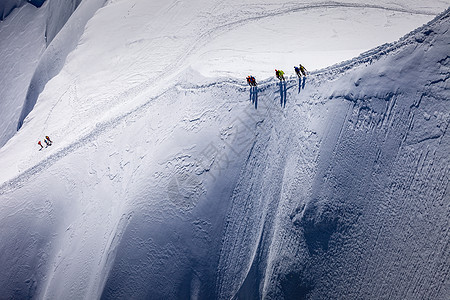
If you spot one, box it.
[101,79,270,299]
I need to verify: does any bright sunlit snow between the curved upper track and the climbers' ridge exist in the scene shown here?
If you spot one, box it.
[193,4,431,78]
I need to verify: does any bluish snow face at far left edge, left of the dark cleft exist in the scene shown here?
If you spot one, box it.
[0,5,46,146]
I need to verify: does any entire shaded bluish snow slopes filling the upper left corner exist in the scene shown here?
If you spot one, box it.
[0,0,98,146]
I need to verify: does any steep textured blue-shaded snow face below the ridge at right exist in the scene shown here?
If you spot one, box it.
[217,11,450,299]
